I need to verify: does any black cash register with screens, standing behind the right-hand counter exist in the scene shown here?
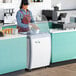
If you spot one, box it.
[42,10,67,29]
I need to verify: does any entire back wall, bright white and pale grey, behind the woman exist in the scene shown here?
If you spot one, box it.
[0,0,76,20]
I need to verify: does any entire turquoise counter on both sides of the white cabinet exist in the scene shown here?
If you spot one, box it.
[0,21,76,74]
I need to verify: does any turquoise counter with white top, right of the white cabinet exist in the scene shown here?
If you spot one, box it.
[50,29,76,63]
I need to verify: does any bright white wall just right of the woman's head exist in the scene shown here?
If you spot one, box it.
[29,0,51,15]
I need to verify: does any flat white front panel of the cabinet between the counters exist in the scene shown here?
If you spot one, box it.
[31,37,51,68]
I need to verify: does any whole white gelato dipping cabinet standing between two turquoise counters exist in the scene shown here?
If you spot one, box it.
[27,33,51,69]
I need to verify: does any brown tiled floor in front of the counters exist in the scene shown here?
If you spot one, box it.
[2,63,76,76]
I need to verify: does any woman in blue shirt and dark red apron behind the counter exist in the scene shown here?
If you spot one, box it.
[16,0,37,32]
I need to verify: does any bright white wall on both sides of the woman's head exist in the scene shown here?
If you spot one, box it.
[0,0,51,19]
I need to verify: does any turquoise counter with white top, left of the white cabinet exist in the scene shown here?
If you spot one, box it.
[0,34,27,75]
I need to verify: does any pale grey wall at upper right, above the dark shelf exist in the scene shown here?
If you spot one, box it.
[51,0,76,9]
